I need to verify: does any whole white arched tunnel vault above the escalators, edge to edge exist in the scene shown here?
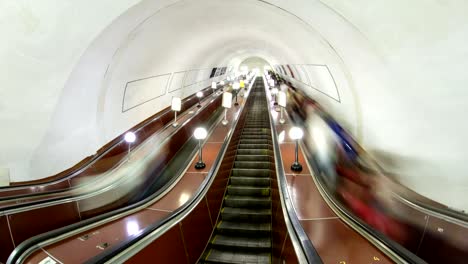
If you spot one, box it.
[0,0,468,208]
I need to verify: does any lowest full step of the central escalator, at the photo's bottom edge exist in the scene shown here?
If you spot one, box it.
[204,249,271,263]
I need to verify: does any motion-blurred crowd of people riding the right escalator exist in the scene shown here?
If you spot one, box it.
[270,72,468,263]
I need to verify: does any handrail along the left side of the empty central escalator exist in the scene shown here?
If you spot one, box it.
[79,73,255,264]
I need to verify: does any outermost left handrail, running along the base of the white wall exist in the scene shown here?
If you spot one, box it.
[0,87,216,192]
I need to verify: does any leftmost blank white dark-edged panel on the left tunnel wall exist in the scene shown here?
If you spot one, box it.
[122,74,171,112]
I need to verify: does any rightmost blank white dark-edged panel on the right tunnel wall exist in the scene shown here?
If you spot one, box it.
[304,65,340,102]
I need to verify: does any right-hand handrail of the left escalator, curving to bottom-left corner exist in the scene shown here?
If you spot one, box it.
[7,94,226,264]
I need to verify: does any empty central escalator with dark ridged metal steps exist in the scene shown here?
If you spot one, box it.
[202,81,274,263]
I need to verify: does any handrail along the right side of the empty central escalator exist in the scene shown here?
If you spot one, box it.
[264,75,322,263]
